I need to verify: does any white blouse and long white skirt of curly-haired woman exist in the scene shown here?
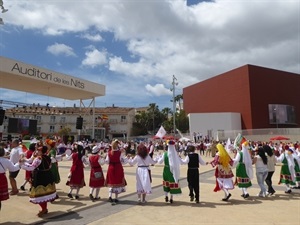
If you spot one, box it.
[129,155,156,194]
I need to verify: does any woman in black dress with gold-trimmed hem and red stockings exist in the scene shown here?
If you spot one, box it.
[22,146,56,216]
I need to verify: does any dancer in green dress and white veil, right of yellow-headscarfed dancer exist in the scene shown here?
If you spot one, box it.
[233,134,253,199]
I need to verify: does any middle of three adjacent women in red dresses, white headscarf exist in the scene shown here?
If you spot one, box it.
[88,146,105,201]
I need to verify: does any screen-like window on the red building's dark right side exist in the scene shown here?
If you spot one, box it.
[269,104,296,125]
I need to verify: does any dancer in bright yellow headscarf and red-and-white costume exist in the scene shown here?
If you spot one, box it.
[210,144,234,201]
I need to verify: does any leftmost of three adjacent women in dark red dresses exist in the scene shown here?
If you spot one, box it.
[66,142,86,199]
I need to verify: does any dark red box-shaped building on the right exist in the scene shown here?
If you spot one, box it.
[183,65,300,129]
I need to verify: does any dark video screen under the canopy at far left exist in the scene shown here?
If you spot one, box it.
[7,118,37,134]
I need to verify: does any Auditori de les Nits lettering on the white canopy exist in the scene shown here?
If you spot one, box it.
[11,62,86,90]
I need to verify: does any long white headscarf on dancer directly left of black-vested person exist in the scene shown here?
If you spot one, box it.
[168,141,180,183]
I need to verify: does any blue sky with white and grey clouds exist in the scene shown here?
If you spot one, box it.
[0,0,300,109]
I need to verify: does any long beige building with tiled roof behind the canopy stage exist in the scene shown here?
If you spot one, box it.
[1,106,135,140]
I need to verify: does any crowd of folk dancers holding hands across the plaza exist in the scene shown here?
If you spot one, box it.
[0,138,300,216]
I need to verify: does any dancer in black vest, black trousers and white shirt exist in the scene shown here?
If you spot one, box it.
[182,145,208,203]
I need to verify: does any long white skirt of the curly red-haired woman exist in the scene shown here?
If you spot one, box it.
[136,167,152,194]
